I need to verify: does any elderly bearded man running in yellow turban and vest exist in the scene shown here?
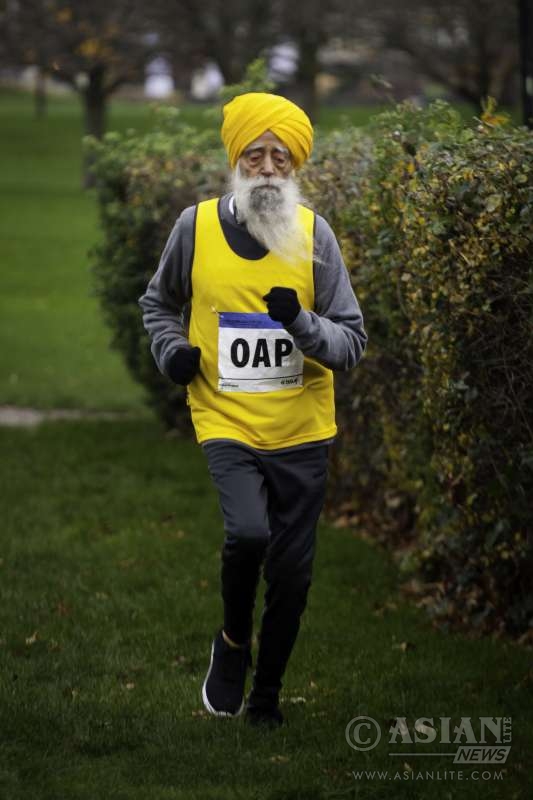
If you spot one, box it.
[139,93,367,727]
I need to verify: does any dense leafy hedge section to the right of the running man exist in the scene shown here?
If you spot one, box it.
[306,102,533,633]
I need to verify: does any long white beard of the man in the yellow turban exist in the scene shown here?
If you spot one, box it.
[231,164,312,263]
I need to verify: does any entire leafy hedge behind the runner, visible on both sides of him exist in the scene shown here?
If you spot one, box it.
[87,102,533,635]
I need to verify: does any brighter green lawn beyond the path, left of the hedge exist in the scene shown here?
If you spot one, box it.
[0,93,150,410]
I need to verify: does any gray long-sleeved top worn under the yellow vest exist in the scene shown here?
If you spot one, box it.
[139,194,368,447]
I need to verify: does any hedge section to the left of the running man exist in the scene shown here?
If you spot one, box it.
[85,107,226,432]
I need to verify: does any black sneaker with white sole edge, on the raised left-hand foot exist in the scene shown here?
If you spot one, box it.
[202,630,252,717]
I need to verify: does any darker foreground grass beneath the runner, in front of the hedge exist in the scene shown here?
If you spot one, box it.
[0,420,533,800]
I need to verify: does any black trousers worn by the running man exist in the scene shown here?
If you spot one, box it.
[204,441,329,696]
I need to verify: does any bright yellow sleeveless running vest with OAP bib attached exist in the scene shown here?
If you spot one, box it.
[187,198,337,450]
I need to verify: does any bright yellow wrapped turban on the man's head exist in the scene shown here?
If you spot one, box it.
[221,92,313,169]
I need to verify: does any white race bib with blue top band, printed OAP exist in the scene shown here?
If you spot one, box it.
[218,311,304,392]
